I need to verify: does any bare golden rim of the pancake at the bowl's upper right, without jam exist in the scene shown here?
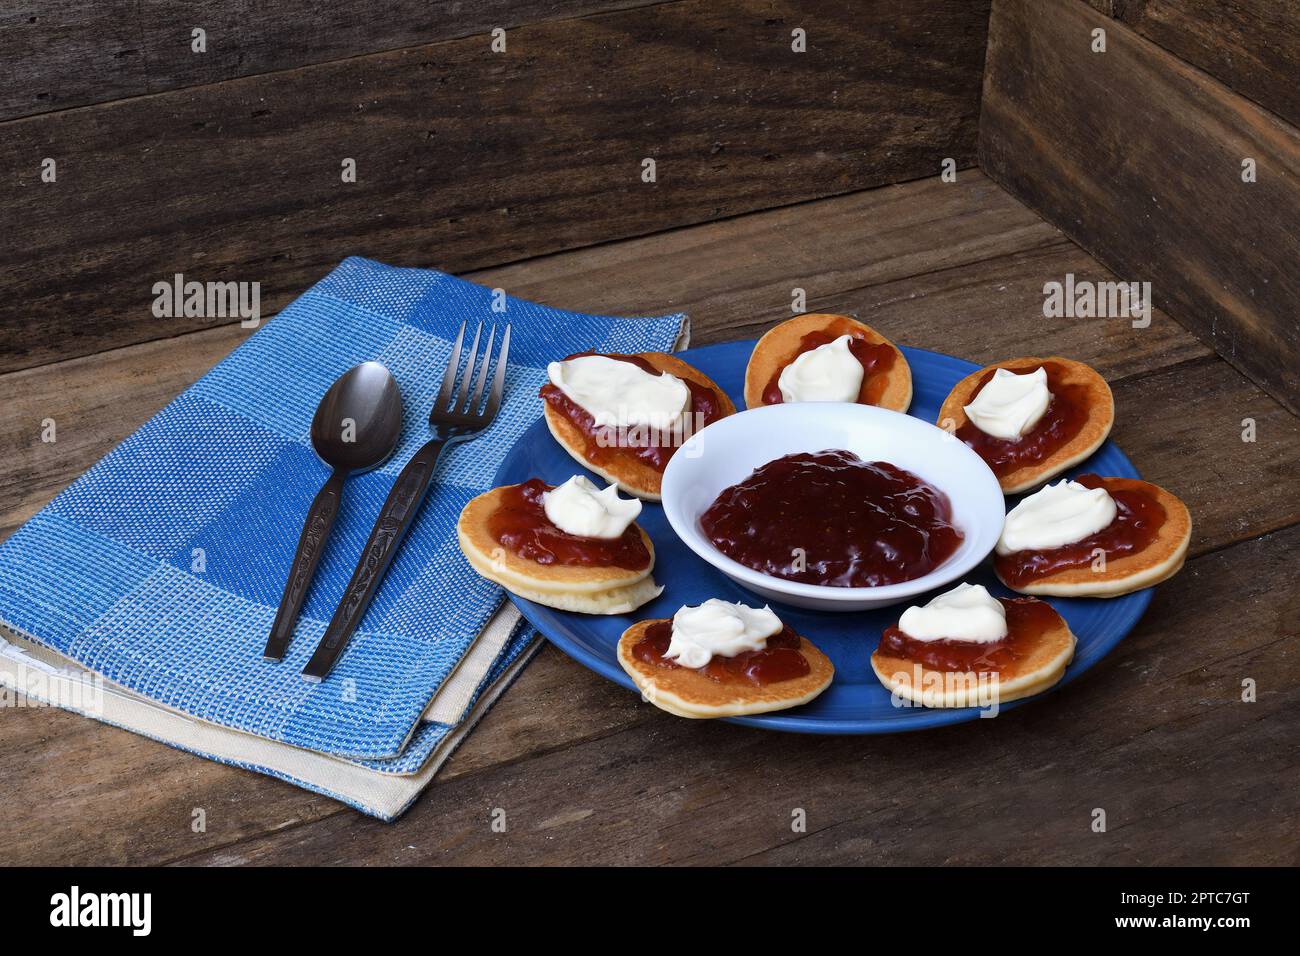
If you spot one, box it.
[936,355,1115,494]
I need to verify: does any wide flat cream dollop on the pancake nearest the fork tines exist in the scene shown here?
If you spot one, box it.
[546,355,690,429]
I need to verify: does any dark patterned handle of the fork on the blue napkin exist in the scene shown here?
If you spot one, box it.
[303,438,447,683]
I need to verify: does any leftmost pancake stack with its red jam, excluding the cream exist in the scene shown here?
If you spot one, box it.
[456,479,663,614]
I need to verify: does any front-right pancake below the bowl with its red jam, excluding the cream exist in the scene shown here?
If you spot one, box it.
[871,585,1076,708]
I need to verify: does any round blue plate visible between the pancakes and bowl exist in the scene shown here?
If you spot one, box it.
[495,342,1152,734]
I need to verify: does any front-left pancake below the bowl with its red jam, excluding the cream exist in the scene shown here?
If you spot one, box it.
[619,601,835,718]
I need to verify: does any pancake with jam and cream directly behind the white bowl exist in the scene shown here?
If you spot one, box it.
[745,312,911,411]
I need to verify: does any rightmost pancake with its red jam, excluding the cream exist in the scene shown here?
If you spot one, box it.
[993,475,1192,597]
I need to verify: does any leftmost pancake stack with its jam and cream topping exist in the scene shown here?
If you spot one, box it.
[456,475,663,614]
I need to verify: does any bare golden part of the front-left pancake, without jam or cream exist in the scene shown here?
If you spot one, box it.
[619,620,835,718]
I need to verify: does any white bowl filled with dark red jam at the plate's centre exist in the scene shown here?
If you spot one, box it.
[663,402,1004,611]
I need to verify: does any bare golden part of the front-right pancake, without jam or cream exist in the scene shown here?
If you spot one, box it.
[871,600,1076,708]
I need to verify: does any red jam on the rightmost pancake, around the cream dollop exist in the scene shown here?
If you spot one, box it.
[993,475,1165,588]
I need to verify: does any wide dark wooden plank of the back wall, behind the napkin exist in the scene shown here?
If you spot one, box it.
[0,0,988,369]
